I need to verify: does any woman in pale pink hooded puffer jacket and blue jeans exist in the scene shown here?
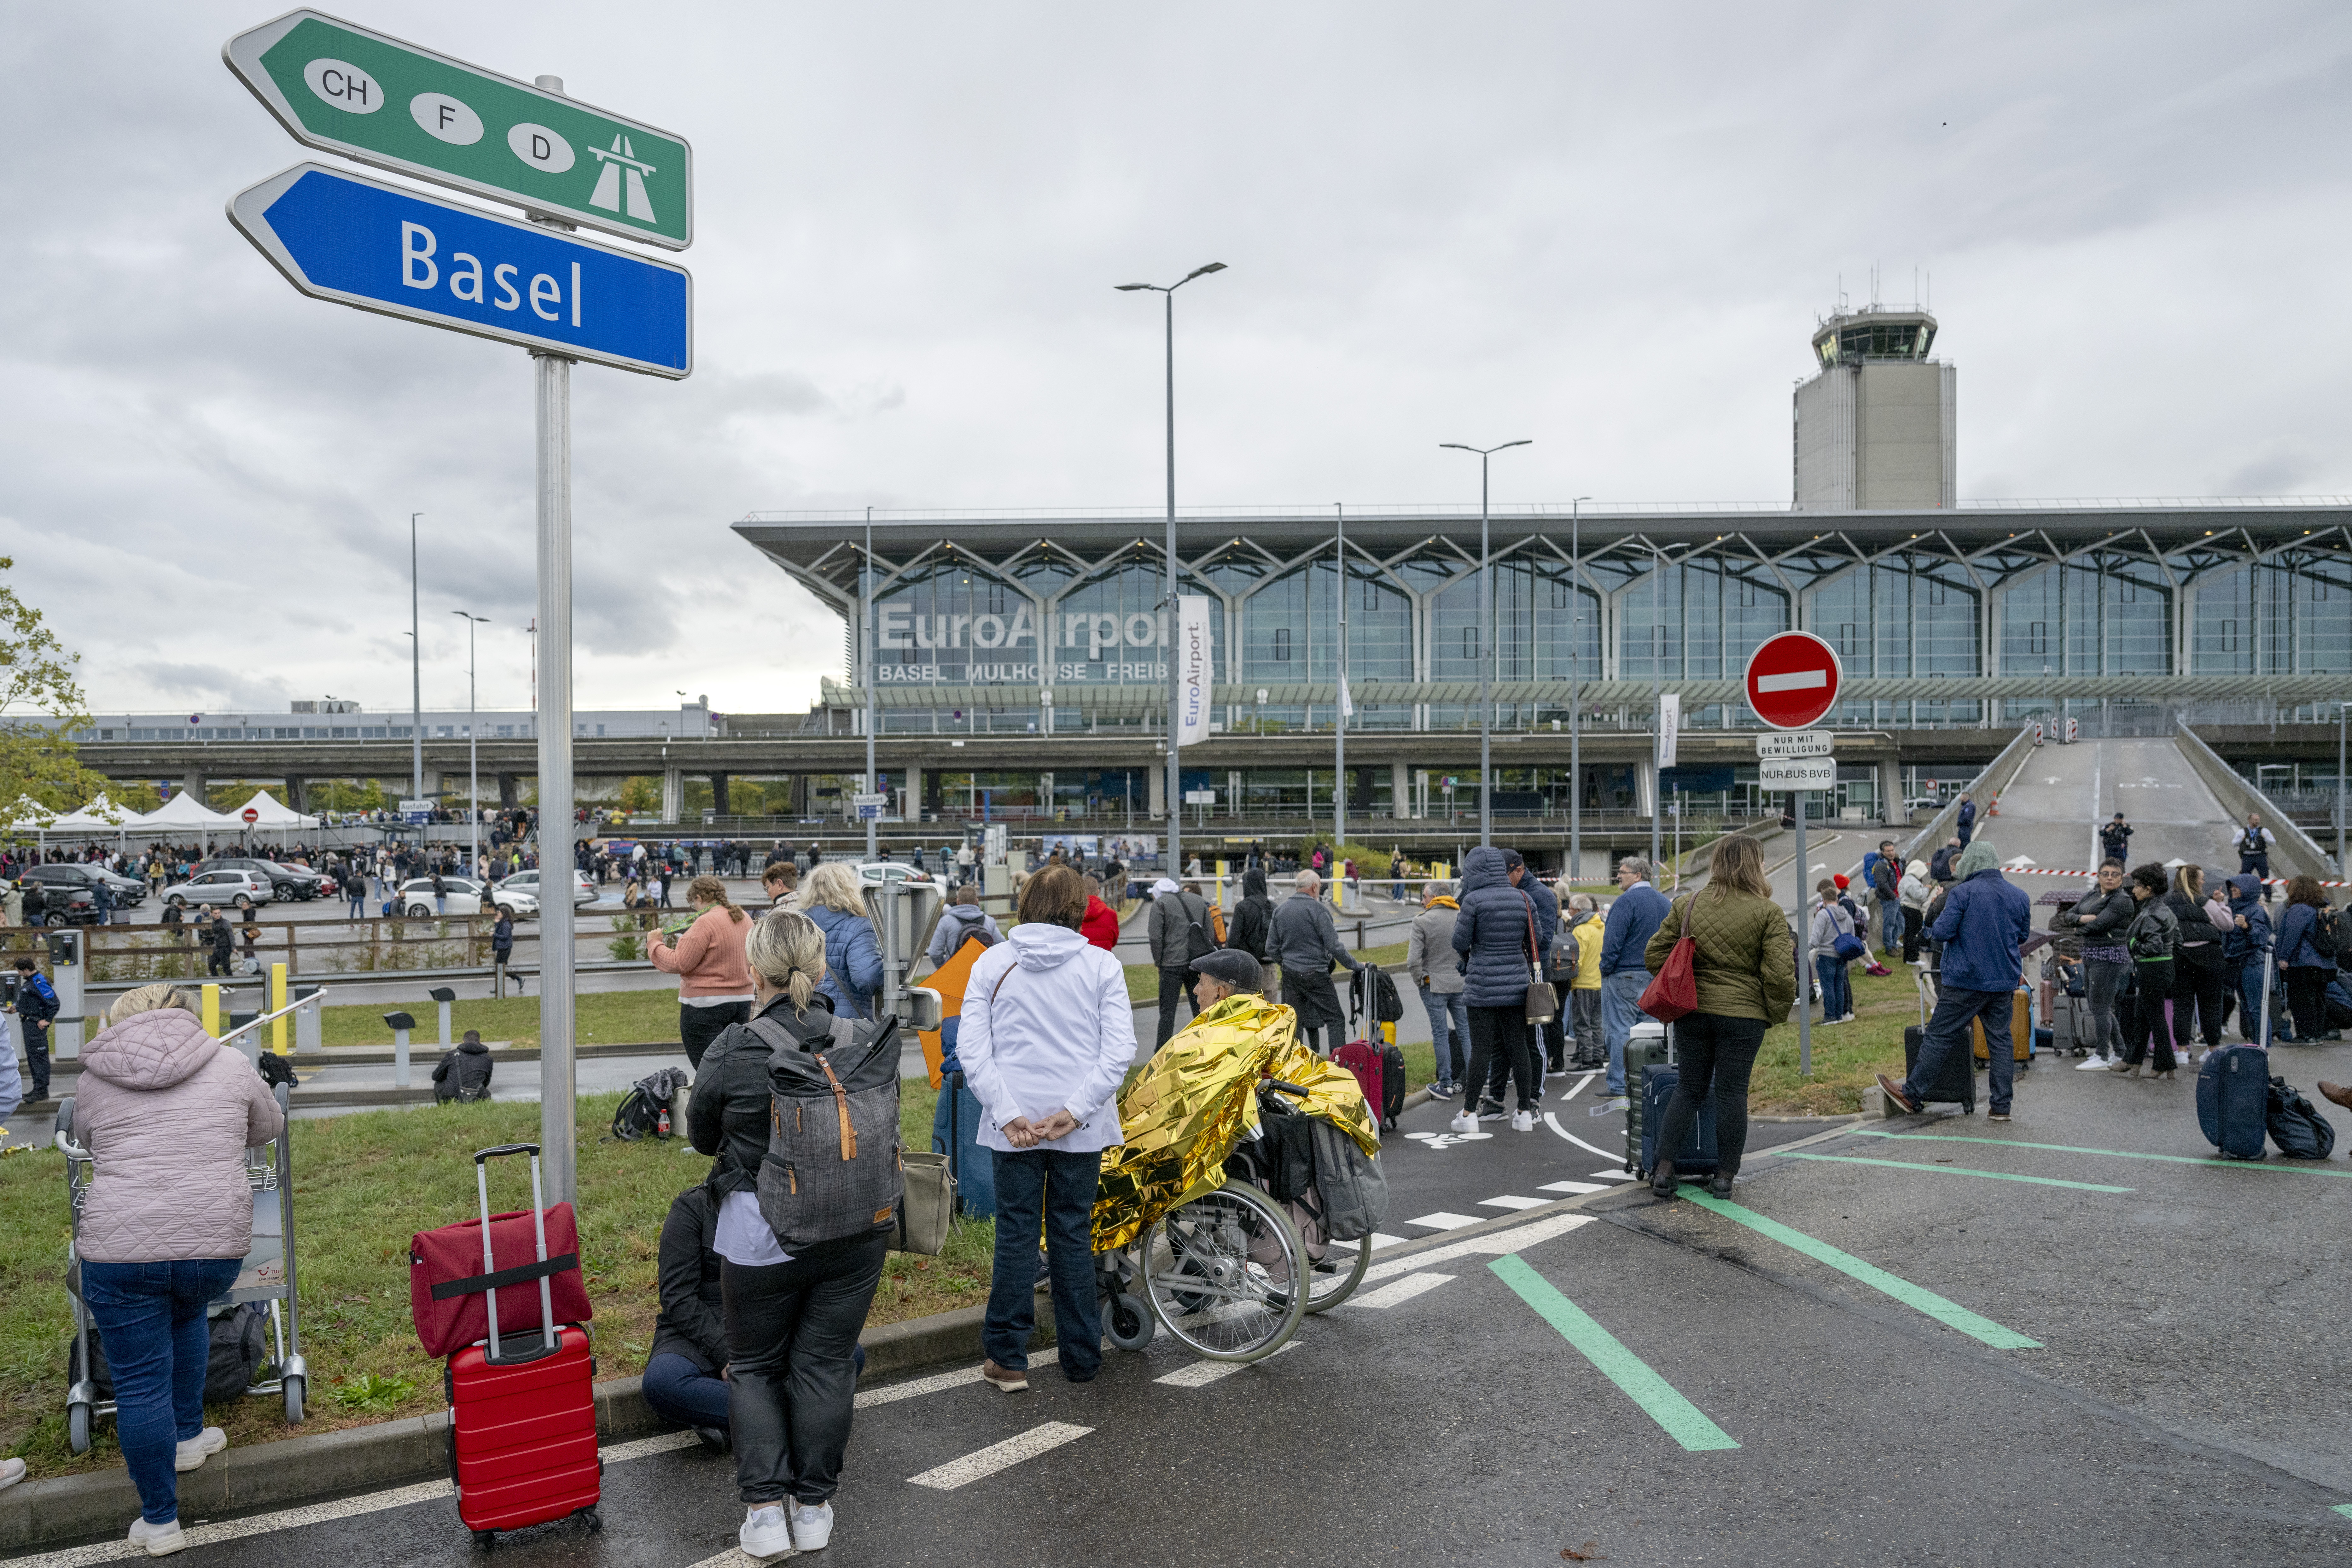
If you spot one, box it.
[73,985,285,1556]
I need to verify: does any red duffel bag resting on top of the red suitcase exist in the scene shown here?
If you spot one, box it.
[409,1170,590,1356]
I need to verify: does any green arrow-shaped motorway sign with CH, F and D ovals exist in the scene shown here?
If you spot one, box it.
[221,12,694,249]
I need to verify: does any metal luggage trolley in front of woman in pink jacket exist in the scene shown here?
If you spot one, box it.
[56,1084,311,1455]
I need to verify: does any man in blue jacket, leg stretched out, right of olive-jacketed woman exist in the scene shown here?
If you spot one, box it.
[1879,839,2035,1121]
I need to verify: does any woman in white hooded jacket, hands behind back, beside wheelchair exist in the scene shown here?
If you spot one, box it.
[955,865,1136,1394]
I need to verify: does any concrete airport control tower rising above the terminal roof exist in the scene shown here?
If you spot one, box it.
[1792,306,1957,512]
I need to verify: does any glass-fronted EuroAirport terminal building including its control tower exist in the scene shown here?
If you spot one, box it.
[736,308,2352,816]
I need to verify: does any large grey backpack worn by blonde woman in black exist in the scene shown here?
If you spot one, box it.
[746,1013,905,1253]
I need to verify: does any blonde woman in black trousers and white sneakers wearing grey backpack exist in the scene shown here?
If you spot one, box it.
[687,910,899,1559]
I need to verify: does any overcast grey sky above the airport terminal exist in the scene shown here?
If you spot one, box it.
[0,0,2352,710]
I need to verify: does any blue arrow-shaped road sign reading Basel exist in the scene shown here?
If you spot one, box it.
[228,165,694,381]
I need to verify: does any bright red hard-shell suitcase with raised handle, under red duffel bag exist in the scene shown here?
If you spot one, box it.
[442,1143,604,1547]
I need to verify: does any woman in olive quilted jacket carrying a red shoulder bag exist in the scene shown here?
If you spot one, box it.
[1627,835,1797,1199]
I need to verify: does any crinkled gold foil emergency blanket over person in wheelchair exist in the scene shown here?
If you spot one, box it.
[1094,992,1381,1253]
